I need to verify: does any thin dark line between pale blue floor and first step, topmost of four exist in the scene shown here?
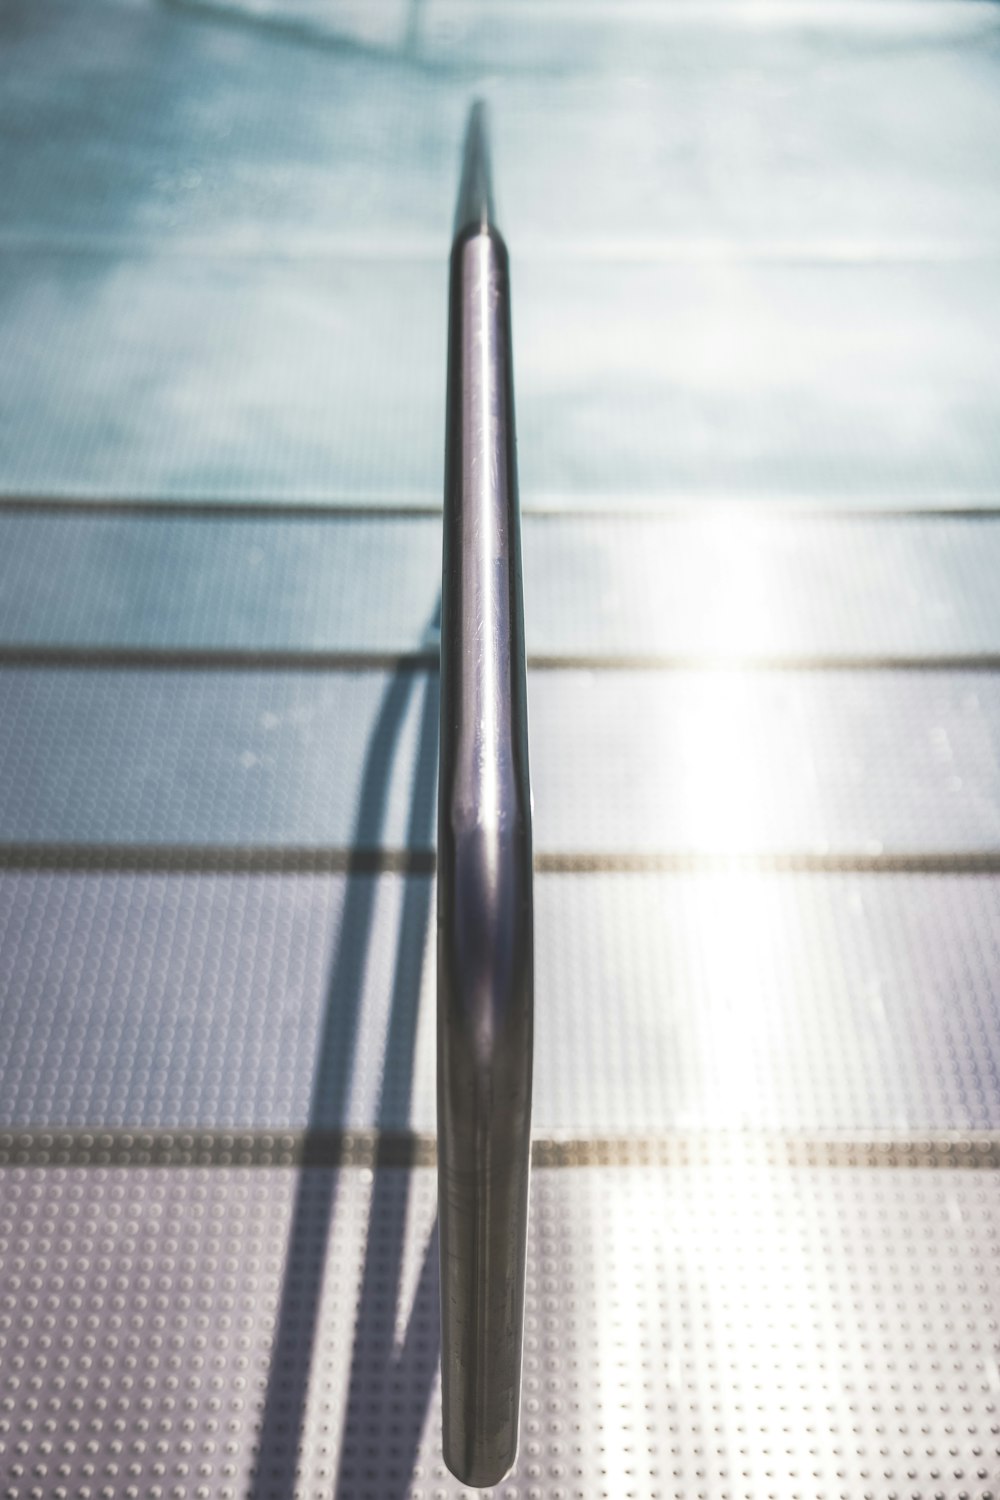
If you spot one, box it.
[0,494,1000,522]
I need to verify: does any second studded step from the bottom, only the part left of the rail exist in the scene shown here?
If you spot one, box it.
[0,873,435,1130]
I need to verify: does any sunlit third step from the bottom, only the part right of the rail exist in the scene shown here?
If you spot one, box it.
[529,671,1000,855]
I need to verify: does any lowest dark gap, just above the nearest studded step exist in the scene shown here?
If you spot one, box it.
[0,1127,1000,1172]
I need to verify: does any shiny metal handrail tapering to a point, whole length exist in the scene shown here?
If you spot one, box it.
[438,105,534,1485]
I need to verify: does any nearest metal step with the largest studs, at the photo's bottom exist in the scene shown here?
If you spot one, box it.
[0,1155,1000,1500]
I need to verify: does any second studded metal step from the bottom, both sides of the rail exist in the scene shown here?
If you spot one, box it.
[0,872,1000,1140]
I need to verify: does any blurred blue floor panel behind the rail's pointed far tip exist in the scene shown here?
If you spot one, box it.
[0,0,1000,258]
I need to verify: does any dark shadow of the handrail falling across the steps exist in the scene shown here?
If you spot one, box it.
[250,611,439,1500]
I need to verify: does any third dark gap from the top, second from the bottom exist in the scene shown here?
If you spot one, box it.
[0,843,1000,876]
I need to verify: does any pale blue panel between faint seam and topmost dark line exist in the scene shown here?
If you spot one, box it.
[0,261,1000,509]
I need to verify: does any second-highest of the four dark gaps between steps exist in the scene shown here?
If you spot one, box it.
[0,644,1000,674]
